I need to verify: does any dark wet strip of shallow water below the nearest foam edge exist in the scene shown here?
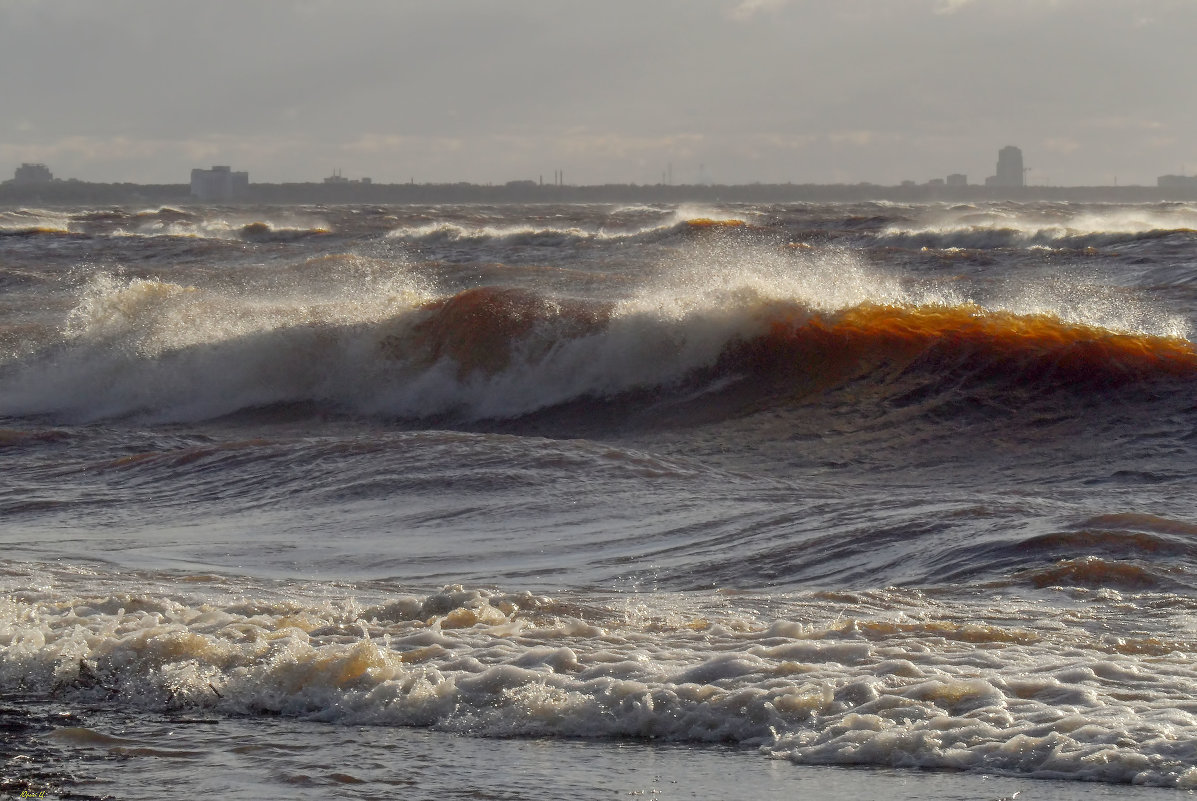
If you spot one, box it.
[7,700,1183,801]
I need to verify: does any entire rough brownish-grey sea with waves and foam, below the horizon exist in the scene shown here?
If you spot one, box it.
[0,201,1197,801]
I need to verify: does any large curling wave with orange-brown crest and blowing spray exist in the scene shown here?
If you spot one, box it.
[0,245,1197,421]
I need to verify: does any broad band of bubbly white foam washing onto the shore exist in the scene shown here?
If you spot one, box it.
[9,569,1197,788]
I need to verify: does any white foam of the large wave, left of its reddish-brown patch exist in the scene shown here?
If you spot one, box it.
[0,265,431,419]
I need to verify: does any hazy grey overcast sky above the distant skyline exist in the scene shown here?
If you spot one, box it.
[0,0,1197,186]
